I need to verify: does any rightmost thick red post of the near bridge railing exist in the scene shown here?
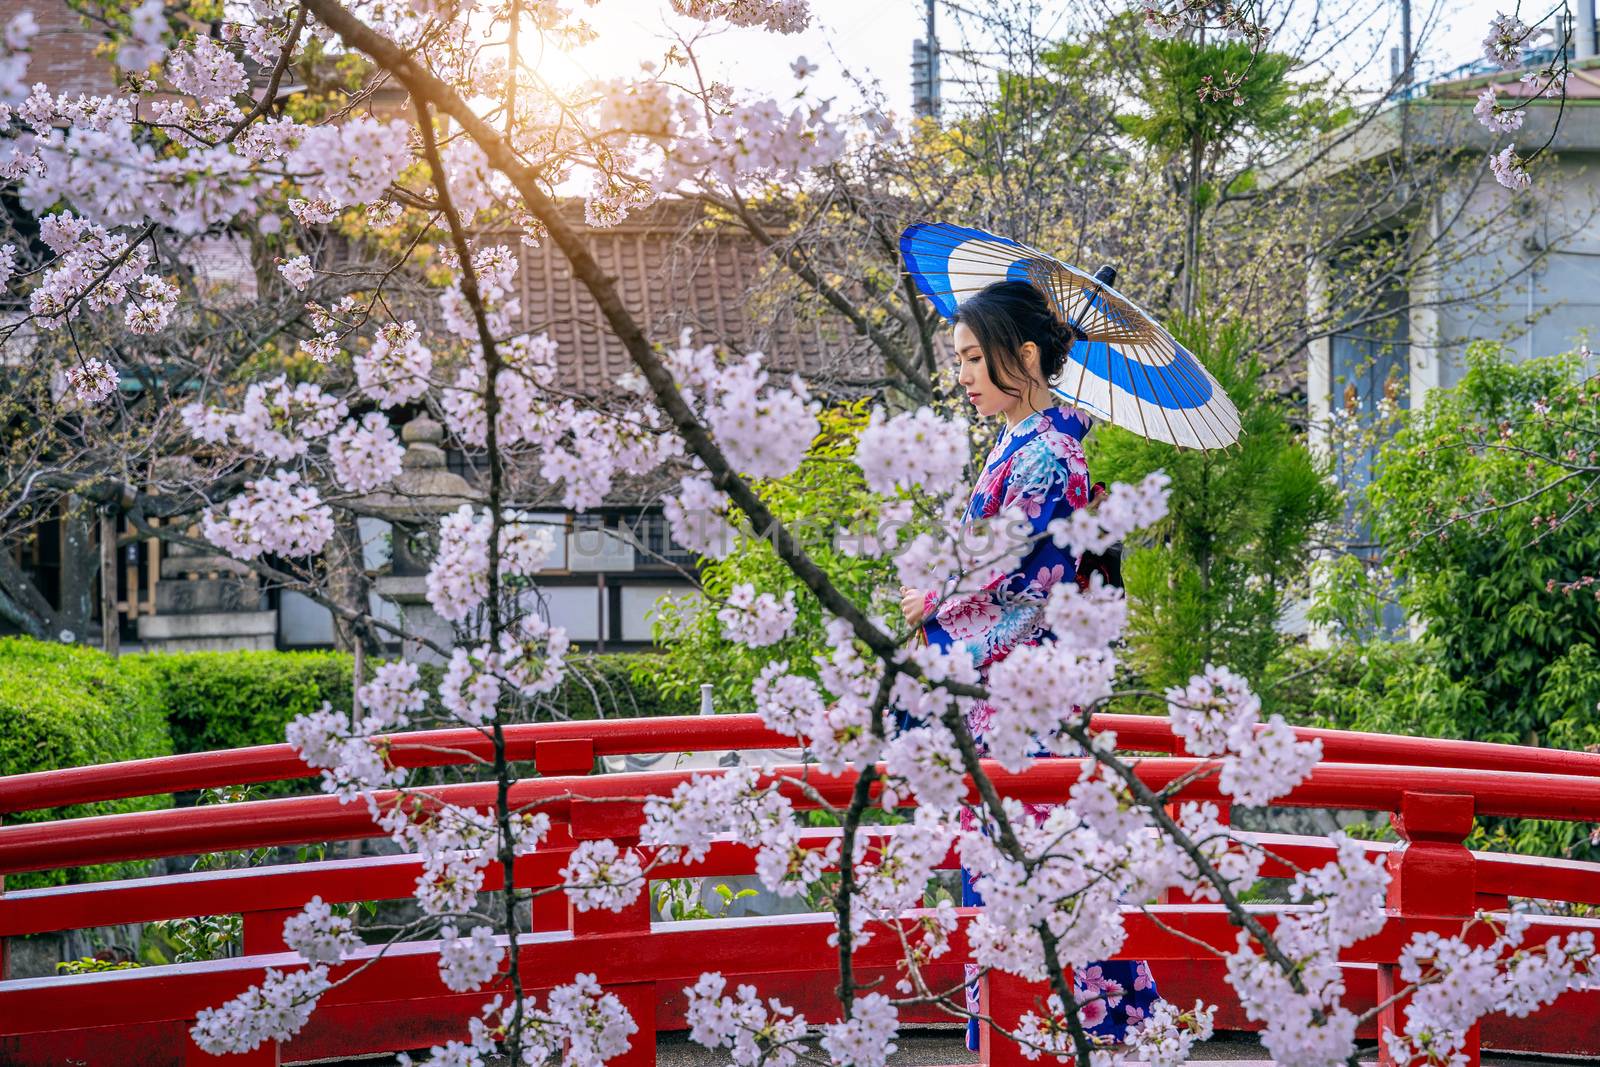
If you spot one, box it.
[1378,792,1478,1067]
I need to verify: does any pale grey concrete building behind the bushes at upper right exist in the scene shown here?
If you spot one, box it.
[1306,51,1600,467]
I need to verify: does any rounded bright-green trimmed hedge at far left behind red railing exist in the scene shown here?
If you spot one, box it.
[0,638,173,889]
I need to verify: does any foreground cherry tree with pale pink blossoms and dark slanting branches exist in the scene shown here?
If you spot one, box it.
[0,0,1597,1067]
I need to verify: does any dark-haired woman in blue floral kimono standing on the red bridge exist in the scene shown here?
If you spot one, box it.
[901,280,1157,1049]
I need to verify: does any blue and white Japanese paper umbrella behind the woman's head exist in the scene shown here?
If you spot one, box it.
[901,222,1238,448]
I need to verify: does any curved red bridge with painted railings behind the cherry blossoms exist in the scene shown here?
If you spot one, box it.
[0,715,1600,1067]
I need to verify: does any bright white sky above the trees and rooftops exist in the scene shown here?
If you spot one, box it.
[541,0,1544,115]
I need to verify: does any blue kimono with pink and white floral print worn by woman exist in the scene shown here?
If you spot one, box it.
[923,406,1157,1049]
